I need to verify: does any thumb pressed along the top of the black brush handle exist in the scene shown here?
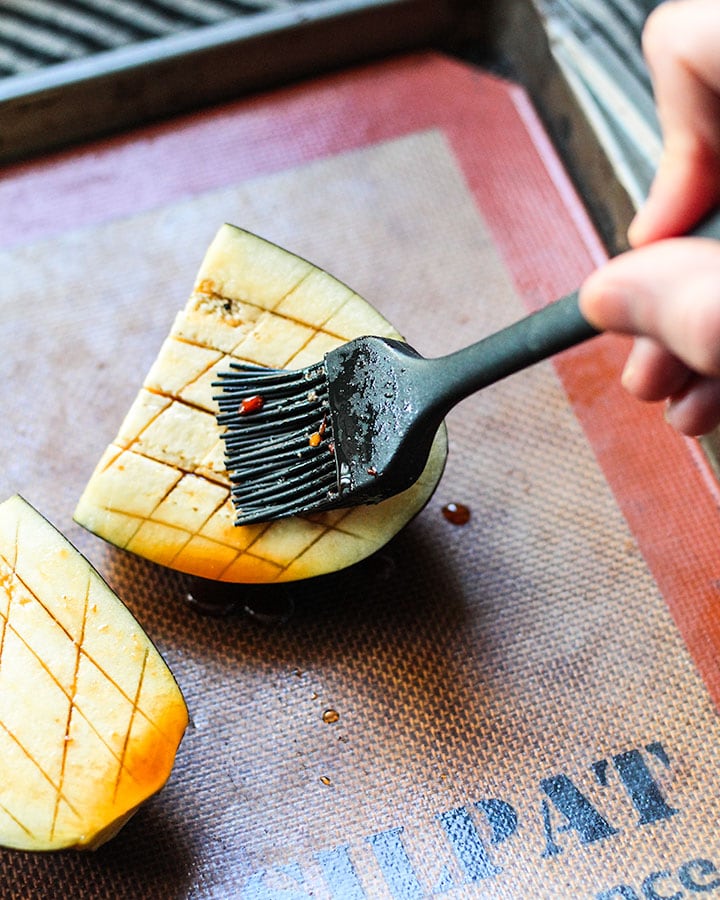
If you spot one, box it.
[580,238,720,377]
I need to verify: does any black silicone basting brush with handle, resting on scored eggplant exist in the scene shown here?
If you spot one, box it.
[215,292,598,525]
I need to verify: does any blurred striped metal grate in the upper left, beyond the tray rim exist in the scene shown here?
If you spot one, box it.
[0,0,307,77]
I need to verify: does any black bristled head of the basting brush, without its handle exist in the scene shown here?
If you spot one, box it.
[215,337,442,525]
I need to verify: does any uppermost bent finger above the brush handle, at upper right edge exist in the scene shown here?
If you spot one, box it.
[629,0,720,246]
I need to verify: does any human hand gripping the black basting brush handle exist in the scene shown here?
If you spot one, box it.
[580,0,720,435]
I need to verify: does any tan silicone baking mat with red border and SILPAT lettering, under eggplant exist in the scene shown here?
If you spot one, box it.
[0,55,720,900]
